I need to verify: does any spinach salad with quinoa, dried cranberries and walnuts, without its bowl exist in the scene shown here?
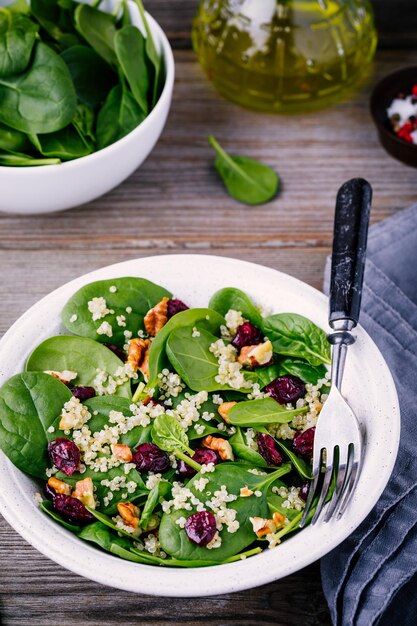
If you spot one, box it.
[0,276,330,568]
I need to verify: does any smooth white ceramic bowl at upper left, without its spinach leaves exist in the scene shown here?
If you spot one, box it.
[0,0,175,215]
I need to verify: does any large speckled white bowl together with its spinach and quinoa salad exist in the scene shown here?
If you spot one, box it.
[0,255,399,596]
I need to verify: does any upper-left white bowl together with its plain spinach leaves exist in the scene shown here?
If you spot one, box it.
[0,0,174,214]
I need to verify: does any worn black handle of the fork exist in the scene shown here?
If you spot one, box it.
[329,178,372,330]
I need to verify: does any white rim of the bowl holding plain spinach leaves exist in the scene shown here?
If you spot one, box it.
[0,11,175,177]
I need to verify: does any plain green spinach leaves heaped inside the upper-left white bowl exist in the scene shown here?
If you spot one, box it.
[0,0,164,166]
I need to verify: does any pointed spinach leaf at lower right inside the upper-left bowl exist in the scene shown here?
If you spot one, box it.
[96,83,146,150]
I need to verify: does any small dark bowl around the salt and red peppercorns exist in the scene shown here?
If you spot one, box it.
[371,66,417,167]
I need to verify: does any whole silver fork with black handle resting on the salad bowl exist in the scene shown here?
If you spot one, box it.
[300,178,372,528]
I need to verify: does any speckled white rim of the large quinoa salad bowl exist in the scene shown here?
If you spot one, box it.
[0,254,400,597]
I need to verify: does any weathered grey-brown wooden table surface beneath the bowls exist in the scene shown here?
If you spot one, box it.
[0,0,416,626]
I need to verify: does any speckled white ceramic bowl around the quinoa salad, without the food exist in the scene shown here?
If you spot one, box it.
[0,255,400,597]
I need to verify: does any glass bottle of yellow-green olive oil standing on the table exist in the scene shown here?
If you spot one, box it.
[192,0,377,113]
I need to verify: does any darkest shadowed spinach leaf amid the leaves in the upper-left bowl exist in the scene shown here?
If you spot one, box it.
[61,45,117,108]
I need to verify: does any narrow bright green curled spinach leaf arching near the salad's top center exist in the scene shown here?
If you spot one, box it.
[147,309,226,389]
